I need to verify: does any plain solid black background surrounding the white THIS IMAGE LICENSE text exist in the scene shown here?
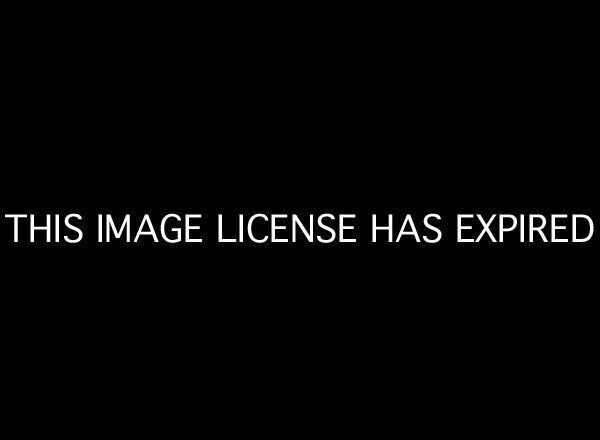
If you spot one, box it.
[1,5,598,433]
